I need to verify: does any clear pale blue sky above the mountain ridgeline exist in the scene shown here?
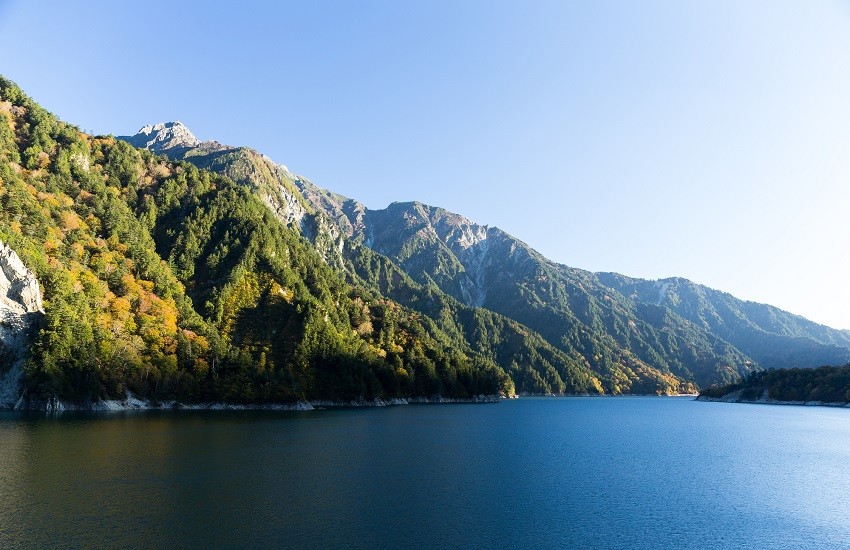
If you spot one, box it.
[0,0,850,329]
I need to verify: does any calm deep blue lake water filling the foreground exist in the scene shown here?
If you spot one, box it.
[0,398,850,548]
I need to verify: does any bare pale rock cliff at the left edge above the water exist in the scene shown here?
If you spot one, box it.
[0,241,44,409]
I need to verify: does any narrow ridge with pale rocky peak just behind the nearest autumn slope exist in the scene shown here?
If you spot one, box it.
[121,129,616,394]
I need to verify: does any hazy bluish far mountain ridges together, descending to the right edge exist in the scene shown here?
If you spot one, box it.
[288,178,850,387]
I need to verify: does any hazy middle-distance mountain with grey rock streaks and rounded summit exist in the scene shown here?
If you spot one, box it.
[338,199,750,385]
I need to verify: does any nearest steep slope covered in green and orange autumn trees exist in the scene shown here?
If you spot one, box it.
[0,79,524,402]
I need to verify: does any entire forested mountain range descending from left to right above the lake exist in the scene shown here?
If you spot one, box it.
[8,78,836,406]
